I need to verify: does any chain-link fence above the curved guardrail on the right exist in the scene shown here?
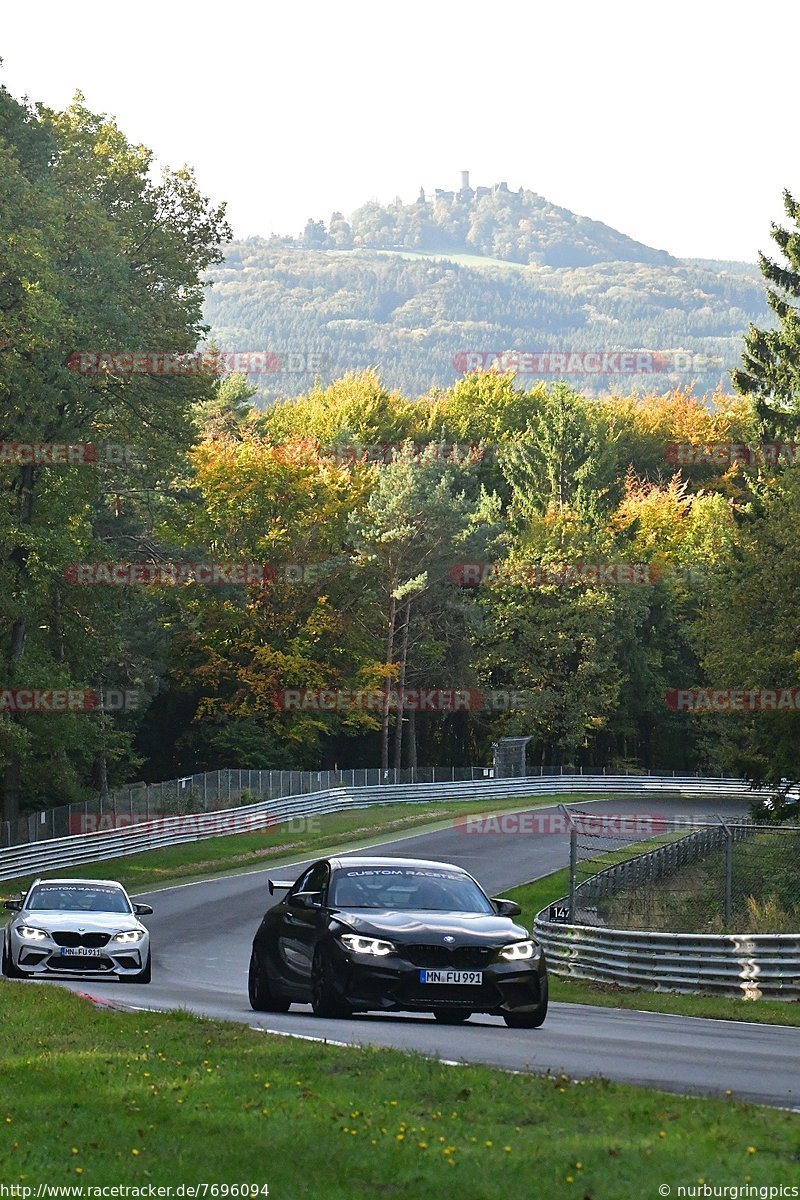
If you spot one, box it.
[563,809,800,934]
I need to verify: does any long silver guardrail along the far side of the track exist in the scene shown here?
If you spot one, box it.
[0,775,753,881]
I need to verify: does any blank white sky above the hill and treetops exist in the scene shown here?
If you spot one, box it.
[0,0,800,260]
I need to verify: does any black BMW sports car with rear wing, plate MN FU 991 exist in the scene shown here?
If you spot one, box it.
[248,856,547,1028]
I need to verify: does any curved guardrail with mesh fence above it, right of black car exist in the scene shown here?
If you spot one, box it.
[534,809,800,1001]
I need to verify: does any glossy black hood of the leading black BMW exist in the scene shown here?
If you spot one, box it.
[332,908,530,946]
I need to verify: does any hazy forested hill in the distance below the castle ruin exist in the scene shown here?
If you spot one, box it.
[205,192,768,403]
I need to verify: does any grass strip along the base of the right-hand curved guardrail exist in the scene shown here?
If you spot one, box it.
[505,870,800,1025]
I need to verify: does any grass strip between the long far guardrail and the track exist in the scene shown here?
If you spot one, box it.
[0,793,616,895]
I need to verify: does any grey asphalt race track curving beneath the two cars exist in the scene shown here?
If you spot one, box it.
[32,797,800,1111]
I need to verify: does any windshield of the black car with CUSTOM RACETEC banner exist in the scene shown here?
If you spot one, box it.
[330,866,494,913]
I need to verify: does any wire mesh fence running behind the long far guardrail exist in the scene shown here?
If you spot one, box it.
[0,767,747,847]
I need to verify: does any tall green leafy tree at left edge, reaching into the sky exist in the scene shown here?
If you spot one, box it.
[0,90,229,818]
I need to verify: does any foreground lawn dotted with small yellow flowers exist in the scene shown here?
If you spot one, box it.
[0,984,798,1200]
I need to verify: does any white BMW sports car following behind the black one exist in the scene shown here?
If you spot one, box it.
[2,880,152,983]
